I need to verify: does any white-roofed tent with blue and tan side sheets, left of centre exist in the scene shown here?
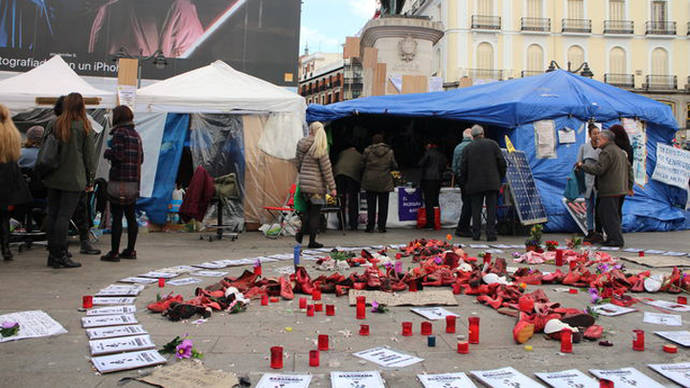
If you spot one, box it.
[119,61,306,231]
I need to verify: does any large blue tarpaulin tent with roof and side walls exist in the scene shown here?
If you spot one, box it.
[307,70,690,231]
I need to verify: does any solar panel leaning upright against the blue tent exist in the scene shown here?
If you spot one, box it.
[502,150,548,225]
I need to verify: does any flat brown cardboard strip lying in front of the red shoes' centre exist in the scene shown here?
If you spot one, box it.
[348,290,458,306]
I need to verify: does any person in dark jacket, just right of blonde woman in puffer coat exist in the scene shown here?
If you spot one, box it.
[335,144,362,230]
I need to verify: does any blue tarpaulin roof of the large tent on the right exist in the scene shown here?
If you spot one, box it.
[307,70,678,129]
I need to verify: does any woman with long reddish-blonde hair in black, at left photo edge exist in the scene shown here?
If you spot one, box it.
[0,105,31,260]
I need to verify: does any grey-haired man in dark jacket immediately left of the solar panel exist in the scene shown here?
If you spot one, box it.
[460,125,506,241]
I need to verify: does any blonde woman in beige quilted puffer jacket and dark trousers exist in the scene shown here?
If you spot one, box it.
[295,121,336,248]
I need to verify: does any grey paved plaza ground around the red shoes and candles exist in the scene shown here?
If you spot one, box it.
[0,230,690,388]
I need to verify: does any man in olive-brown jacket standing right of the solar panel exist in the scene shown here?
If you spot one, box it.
[577,131,634,247]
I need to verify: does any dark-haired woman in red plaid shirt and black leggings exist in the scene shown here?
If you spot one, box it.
[101,105,144,261]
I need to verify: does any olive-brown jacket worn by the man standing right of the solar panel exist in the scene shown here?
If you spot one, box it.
[582,142,634,197]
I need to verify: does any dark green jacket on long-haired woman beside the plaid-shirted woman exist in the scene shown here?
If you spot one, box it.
[43,121,96,191]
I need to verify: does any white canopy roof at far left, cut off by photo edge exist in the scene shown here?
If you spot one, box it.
[0,55,116,111]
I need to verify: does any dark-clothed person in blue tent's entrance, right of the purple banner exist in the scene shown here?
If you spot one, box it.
[417,142,446,229]
